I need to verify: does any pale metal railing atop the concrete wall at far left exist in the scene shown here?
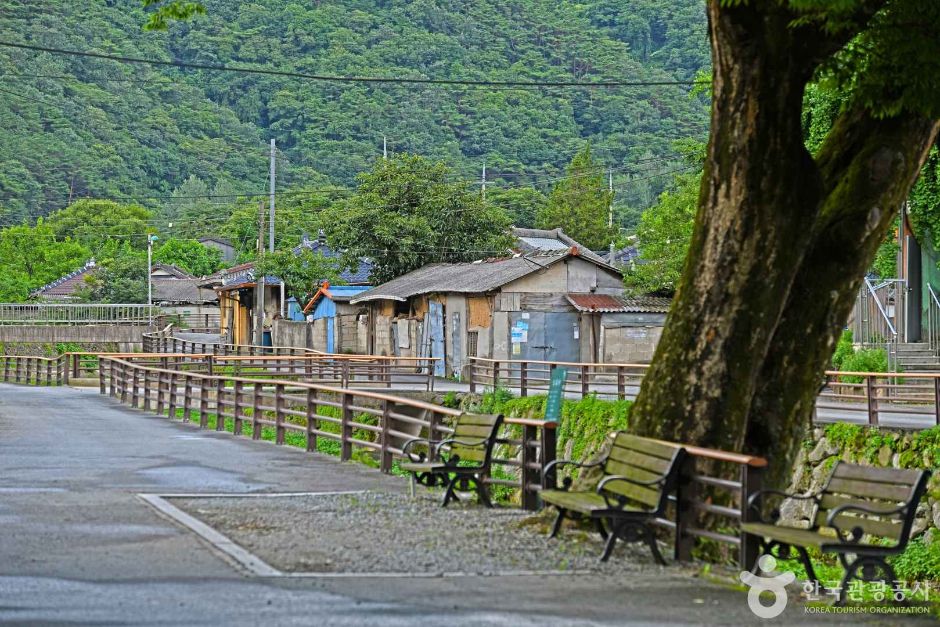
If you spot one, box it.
[0,303,159,325]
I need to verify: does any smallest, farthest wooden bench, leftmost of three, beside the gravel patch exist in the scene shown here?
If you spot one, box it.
[401,414,503,507]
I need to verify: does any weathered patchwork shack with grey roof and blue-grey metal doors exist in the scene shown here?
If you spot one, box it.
[350,247,623,376]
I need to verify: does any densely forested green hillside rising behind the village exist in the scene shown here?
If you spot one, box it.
[0,0,708,225]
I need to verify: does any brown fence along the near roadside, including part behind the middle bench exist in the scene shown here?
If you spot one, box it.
[3,353,767,565]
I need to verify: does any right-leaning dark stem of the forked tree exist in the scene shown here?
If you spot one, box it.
[745,111,938,487]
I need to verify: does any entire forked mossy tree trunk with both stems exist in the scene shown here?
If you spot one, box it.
[631,0,937,484]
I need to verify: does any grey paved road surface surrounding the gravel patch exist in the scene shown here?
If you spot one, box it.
[0,385,924,625]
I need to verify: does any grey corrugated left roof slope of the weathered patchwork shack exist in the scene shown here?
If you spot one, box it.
[350,250,569,304]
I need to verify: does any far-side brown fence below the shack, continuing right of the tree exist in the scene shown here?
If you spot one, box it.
[469,357,940,429]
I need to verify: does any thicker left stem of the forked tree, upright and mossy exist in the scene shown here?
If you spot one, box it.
[631,2,822,450]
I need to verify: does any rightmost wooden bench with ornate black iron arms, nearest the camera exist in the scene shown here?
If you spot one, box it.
[741,461,930,603]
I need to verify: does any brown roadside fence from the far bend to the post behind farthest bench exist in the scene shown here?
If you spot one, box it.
[98,356,555,508]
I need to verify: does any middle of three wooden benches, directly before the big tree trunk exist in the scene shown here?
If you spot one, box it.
[539,431,686,564]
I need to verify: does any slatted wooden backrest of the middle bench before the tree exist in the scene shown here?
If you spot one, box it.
[604,431,686,512]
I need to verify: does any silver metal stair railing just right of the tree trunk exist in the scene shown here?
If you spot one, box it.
[850,277,906,372]
